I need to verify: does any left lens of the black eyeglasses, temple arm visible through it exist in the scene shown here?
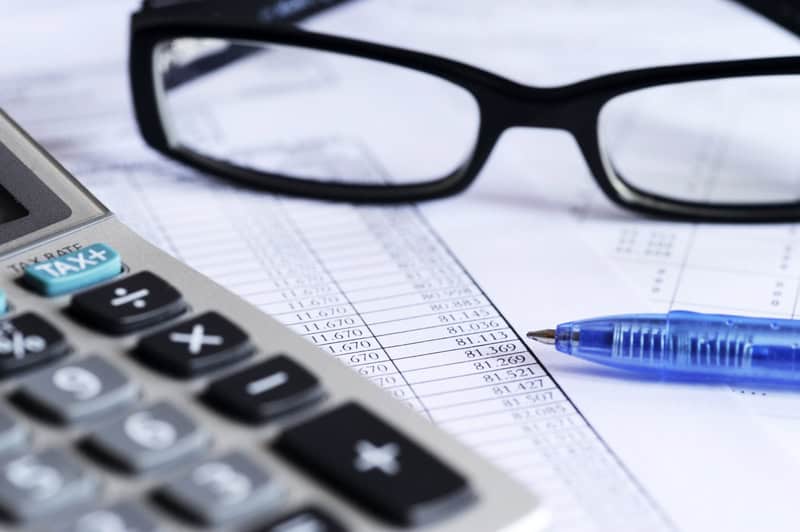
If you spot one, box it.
[155,38,480,185]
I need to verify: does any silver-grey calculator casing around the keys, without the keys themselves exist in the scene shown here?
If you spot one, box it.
[0,109,546,532]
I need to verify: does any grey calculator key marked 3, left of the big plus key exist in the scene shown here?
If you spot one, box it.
[159,452,284,526]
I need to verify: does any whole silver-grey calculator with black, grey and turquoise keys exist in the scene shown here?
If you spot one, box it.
[0,112,546,532]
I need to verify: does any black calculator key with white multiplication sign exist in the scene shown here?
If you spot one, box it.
[136,312,253,377]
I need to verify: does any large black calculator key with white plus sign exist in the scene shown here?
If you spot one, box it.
[275,403,475,526]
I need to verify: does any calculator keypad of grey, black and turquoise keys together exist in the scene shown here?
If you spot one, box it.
[0,244,482,532]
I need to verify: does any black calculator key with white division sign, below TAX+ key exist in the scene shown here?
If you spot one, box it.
[70,272,186,334]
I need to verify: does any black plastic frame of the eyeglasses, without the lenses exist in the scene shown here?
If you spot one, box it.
[129,1,800,222]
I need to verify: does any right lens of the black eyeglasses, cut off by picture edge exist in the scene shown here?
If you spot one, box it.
[599,75,800,205]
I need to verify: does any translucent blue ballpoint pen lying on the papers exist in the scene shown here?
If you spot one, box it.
[528,310,800,382]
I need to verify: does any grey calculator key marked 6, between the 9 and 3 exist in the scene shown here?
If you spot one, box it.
[89,401,209,473]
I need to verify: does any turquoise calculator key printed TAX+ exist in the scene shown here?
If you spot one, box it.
[24,243,122,296]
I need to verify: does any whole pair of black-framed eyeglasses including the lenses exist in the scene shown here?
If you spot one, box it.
[130,0,800,221]
